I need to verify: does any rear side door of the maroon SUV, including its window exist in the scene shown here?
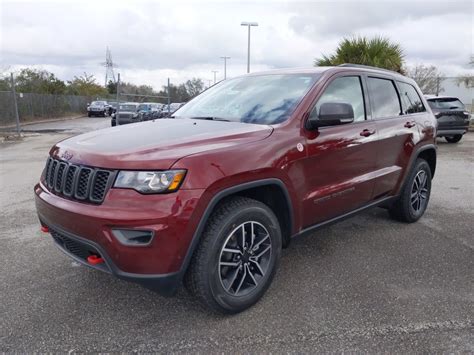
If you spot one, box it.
[366,75,420,199]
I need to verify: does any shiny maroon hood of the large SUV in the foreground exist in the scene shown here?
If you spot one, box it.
[50,119,273,169]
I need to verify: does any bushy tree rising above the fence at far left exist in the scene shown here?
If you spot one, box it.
[15,68,66,94]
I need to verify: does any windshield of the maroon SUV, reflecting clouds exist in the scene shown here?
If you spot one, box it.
[174,74,319,124]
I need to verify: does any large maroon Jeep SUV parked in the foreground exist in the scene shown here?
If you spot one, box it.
[35,65,436,313]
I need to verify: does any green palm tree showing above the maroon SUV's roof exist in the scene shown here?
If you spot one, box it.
[314,37,404,73]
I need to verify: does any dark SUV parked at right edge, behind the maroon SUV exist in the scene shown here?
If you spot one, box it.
[426,95,471,143]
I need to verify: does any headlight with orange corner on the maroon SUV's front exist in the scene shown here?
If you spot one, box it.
[114,170,186,194]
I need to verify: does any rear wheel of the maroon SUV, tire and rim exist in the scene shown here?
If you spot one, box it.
[389,158,431,223]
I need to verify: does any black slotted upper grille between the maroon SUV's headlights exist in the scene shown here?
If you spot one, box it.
[44,158,115,203]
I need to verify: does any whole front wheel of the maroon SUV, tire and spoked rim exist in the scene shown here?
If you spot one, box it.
[184,197,282,314]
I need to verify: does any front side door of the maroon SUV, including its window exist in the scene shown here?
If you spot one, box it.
[302,75,378,228]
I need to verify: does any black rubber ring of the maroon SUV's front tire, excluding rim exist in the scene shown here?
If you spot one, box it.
[206,206,282,313]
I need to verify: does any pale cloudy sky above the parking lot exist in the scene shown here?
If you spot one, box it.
[0,0,474,88]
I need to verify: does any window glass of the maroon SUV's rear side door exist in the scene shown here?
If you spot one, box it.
[367,77,401,119]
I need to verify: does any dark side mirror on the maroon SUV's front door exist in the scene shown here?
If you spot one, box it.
[306,102,354,130]
